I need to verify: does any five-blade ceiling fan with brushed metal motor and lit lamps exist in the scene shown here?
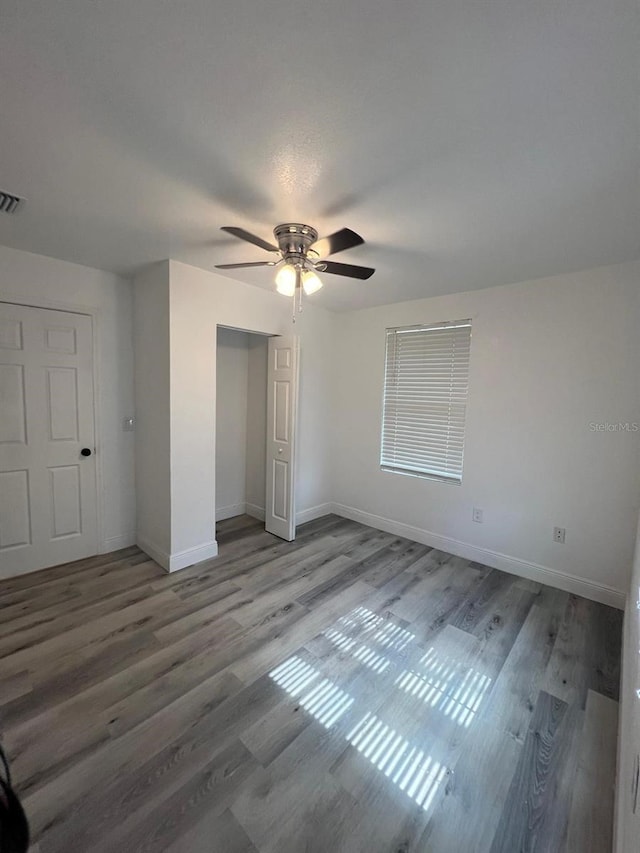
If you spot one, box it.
[216,222,375,310]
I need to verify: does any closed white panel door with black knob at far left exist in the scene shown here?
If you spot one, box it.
[0,302,98,577]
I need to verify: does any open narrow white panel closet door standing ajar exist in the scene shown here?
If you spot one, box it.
[265,335,300,542]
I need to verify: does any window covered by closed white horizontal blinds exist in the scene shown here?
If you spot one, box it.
[380,320,471,483]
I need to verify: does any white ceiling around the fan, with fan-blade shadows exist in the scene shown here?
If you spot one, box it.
[0,0,640,310]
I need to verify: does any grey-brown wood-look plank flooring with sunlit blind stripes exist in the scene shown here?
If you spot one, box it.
[0,516,622,853]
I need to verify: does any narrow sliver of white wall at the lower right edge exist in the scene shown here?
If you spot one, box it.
[615,523,640,853]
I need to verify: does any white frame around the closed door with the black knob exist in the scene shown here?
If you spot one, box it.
[0,291,104,554]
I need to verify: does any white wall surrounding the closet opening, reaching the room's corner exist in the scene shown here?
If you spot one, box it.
[168,261,331,569]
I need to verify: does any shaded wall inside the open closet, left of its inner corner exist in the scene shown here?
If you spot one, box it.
[215,328,249,520]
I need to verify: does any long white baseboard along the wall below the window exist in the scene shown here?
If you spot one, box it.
[328,503,626,610]
